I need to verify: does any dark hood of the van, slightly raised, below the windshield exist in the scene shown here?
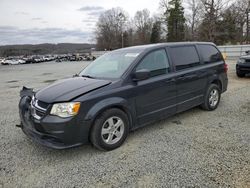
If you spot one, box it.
[35,77,111,103]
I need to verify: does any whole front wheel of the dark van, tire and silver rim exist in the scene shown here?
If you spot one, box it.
[90,108,129,151]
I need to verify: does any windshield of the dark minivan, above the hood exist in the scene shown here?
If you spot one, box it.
[79,50,141,78]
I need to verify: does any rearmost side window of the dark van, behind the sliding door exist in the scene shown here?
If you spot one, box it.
[198,44,223,64]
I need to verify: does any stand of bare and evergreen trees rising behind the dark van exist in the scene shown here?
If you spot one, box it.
[95,0,250,50]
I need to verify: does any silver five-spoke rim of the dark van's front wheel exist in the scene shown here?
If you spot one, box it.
[101,116,124,144]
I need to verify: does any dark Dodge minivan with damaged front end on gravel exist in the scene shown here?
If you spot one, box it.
[19,42,228,150]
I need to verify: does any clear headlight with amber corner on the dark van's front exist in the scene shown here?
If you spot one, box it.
[50,102,80,118]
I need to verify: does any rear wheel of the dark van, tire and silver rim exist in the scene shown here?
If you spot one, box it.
[201,84,221,111]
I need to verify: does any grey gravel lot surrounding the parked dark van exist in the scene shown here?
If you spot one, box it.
[0,62,250,187]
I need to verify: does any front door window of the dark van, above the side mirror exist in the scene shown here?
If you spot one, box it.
[136,49,170,77]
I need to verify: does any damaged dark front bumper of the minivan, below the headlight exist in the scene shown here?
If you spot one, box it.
[19,96,90,149]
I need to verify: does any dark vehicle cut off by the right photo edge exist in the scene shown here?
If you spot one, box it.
[236,51,250,78]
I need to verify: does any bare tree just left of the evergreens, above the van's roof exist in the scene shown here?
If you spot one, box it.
[134,9,152,44]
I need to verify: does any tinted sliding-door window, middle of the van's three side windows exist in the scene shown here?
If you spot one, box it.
[170,46,200,71]
